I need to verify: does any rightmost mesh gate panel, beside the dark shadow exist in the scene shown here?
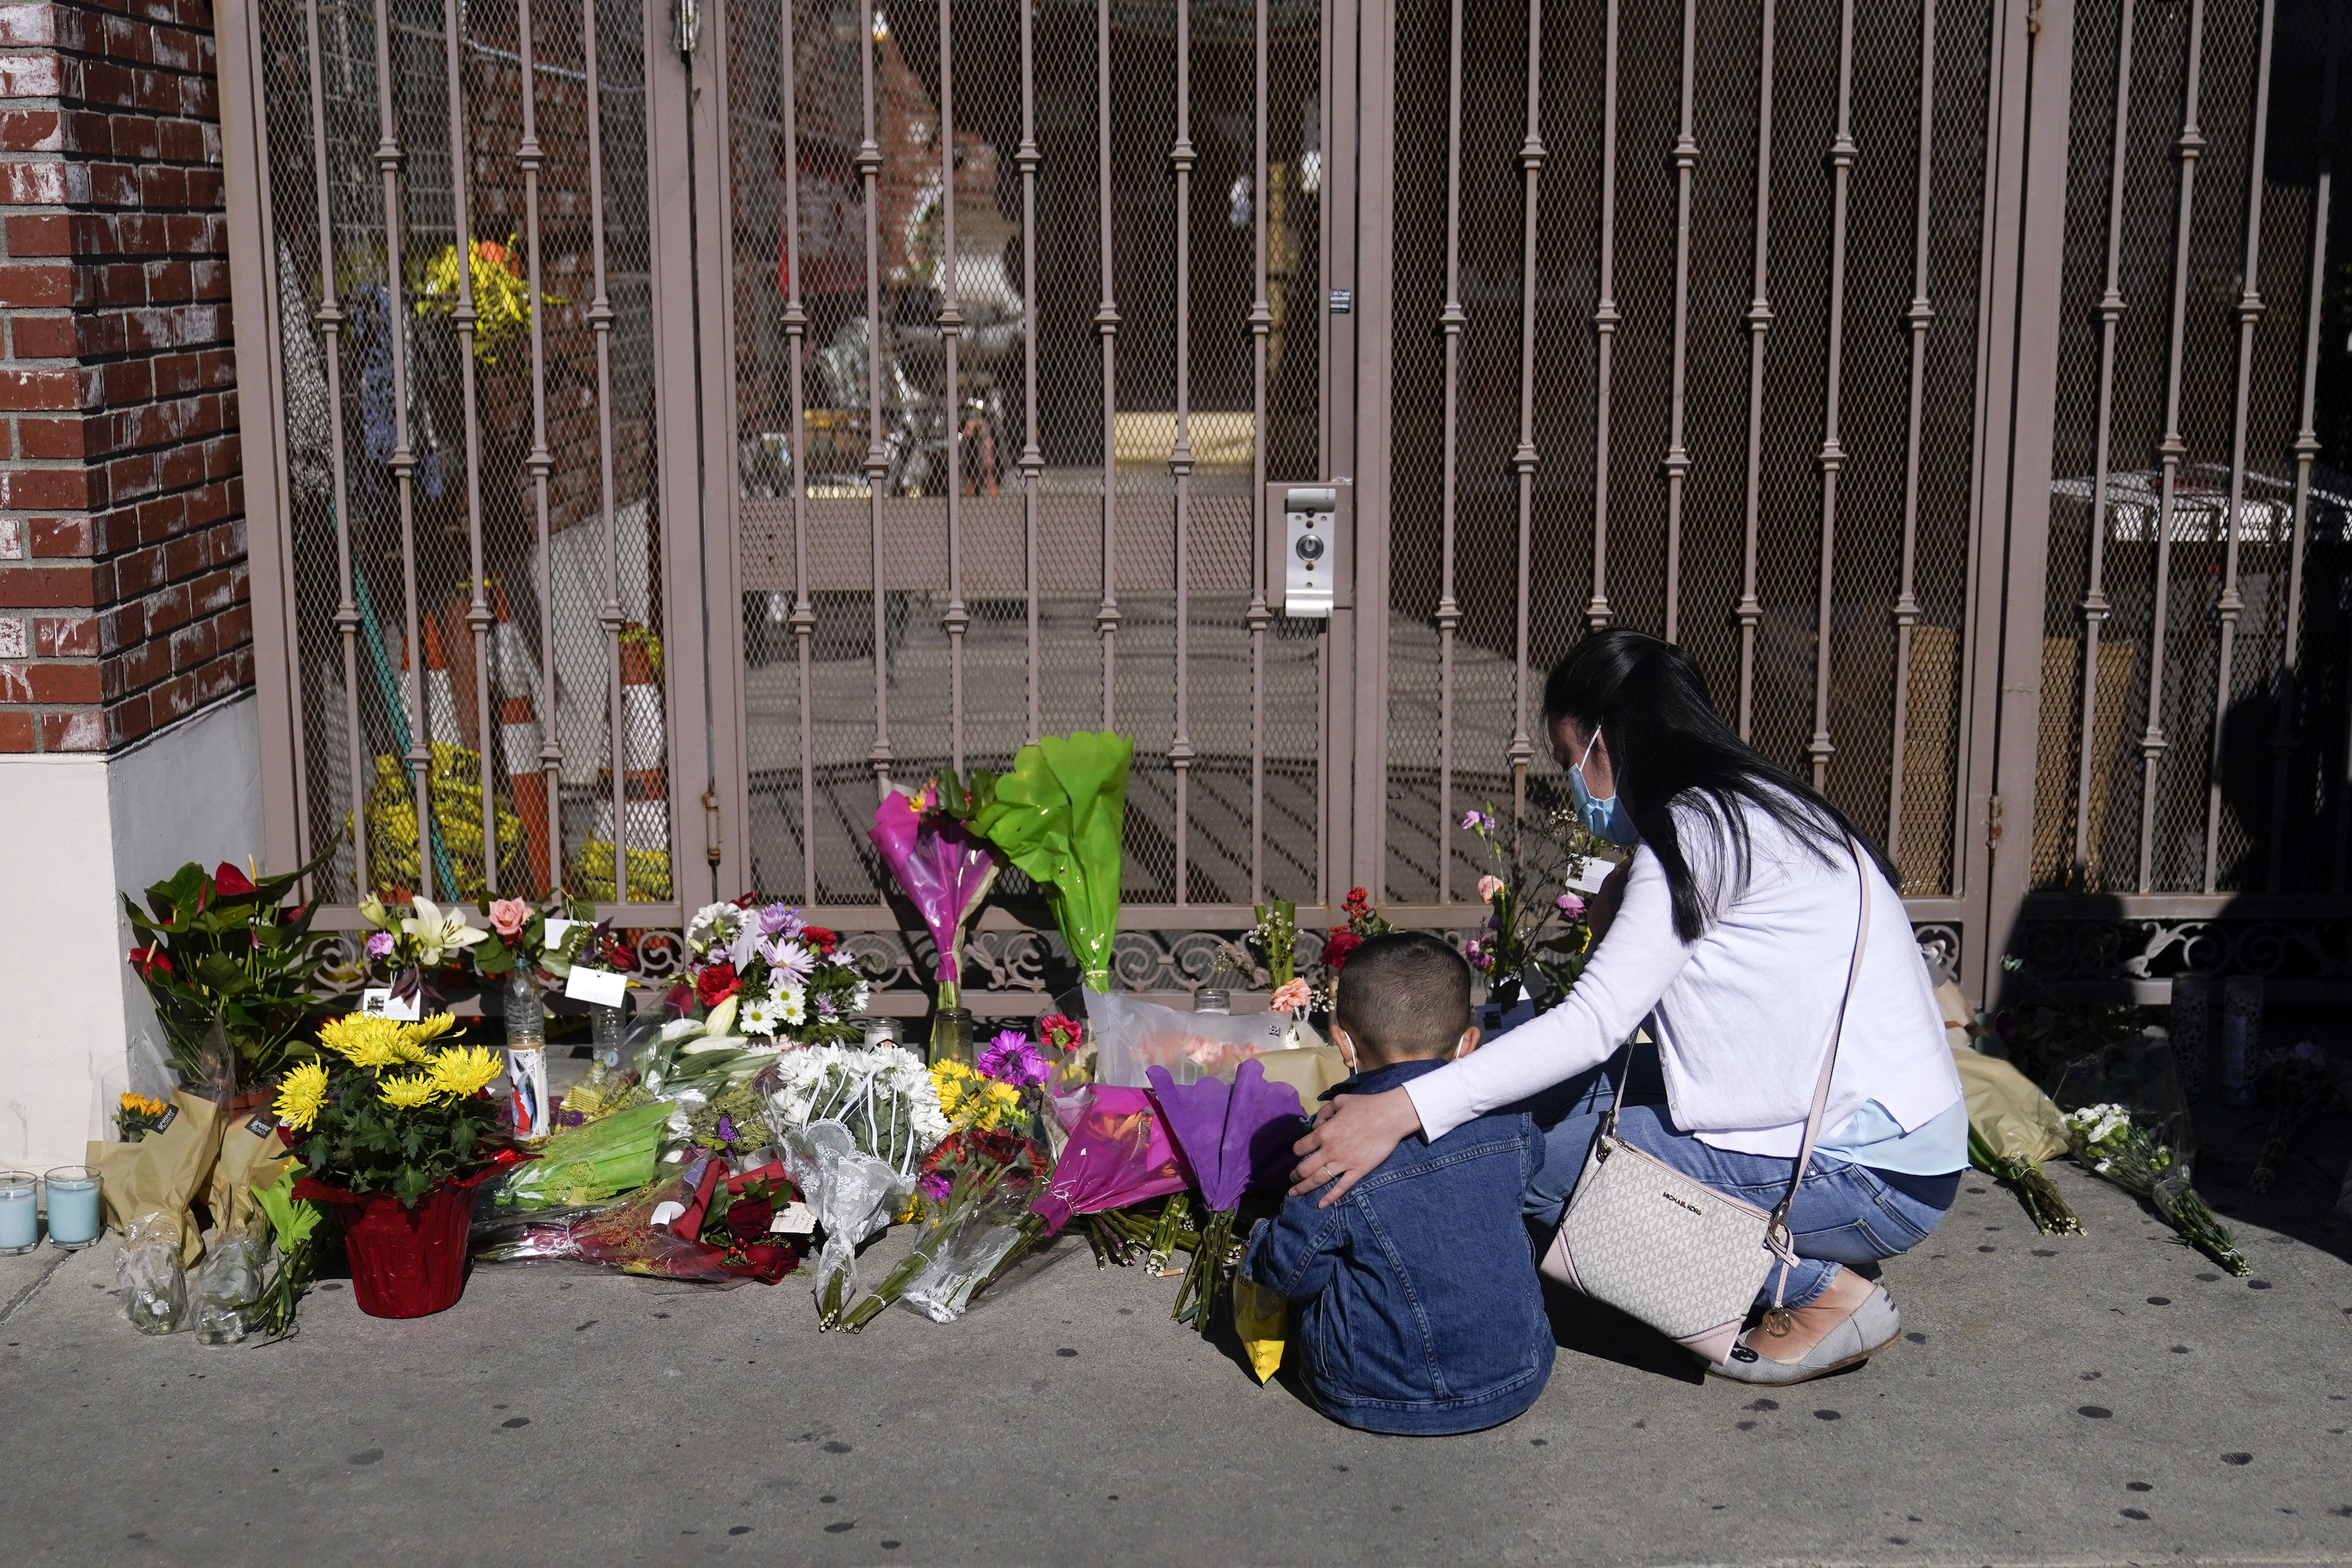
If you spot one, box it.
[2032,0,2352,893]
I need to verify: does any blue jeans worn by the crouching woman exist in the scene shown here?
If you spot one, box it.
[1520,1049,1945,1307]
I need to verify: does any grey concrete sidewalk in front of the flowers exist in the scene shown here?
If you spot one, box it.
[0,1119,2352,1568]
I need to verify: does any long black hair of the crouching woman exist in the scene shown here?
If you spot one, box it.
[1543,630,1903,943]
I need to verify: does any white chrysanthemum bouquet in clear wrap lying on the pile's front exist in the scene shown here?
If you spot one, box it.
[762,1044,953,1328]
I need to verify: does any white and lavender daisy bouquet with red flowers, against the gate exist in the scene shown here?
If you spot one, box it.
[673,900,868,1046]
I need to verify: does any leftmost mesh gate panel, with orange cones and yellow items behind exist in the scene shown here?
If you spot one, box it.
[254,0,670,903]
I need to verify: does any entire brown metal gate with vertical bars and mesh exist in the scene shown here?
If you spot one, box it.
[221,0,2352,1011]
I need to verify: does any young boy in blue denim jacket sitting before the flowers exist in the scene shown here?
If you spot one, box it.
[1242,931,1552,1434]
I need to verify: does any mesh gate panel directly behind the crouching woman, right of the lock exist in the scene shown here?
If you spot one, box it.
[1388,0,1992,903]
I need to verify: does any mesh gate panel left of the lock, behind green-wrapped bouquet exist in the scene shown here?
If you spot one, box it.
[724,0,1324,919]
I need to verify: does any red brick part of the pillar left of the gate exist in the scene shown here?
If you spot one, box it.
[0,0,241,752]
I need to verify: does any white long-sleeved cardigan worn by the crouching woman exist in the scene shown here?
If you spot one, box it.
[1406,802,1959,1157]
